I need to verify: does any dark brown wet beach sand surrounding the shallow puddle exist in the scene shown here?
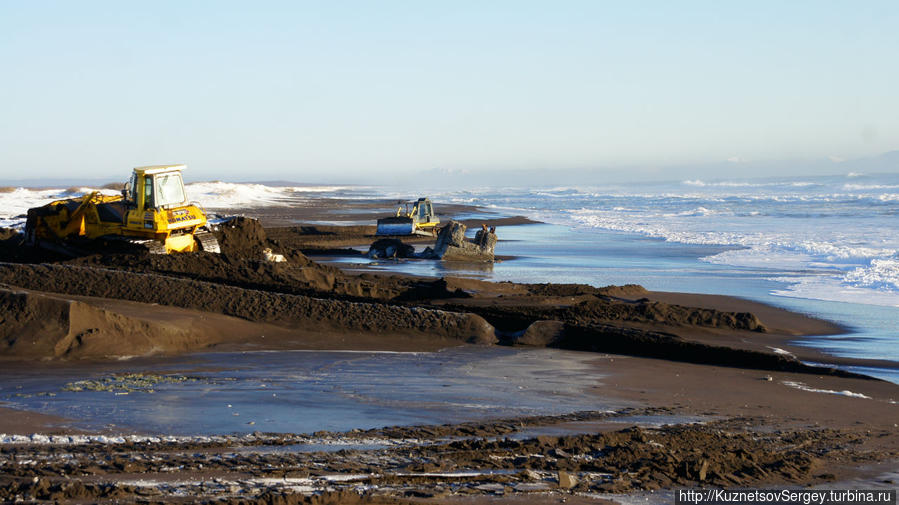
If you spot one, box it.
[0,201,899,503]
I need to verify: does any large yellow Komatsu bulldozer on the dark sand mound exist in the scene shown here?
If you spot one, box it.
[25,165,220,256]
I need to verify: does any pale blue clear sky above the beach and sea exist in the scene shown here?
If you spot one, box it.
[0,0,899,183]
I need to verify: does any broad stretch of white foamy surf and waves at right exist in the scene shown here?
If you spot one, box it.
[549,177,899,306]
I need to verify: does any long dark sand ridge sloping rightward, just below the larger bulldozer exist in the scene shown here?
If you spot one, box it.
[0,265,496,354]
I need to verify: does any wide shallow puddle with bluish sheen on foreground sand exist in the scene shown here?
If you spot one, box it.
[0,347,628,435]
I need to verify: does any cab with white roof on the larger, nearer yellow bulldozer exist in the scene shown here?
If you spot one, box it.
[122,165,188,212]
